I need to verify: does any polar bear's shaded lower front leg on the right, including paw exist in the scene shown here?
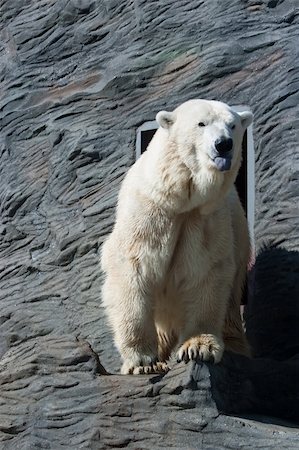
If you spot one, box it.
[177,270,233,363]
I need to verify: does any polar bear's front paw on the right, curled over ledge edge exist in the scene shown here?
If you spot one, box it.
[177,334,224,364]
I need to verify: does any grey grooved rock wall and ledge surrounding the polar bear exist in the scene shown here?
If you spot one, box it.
[0,0,299,450]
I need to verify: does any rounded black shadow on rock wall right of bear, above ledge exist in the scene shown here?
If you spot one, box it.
[244,246,299,361]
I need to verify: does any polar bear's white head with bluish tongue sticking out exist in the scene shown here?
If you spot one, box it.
[156,100,253,176]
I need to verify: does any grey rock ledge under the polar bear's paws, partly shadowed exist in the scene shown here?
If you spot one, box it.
[0,336,299,450]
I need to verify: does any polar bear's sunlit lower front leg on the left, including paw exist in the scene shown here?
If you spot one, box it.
[103,277,167,374]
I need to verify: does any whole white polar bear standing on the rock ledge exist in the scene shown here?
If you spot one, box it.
[101,100,252,374]
